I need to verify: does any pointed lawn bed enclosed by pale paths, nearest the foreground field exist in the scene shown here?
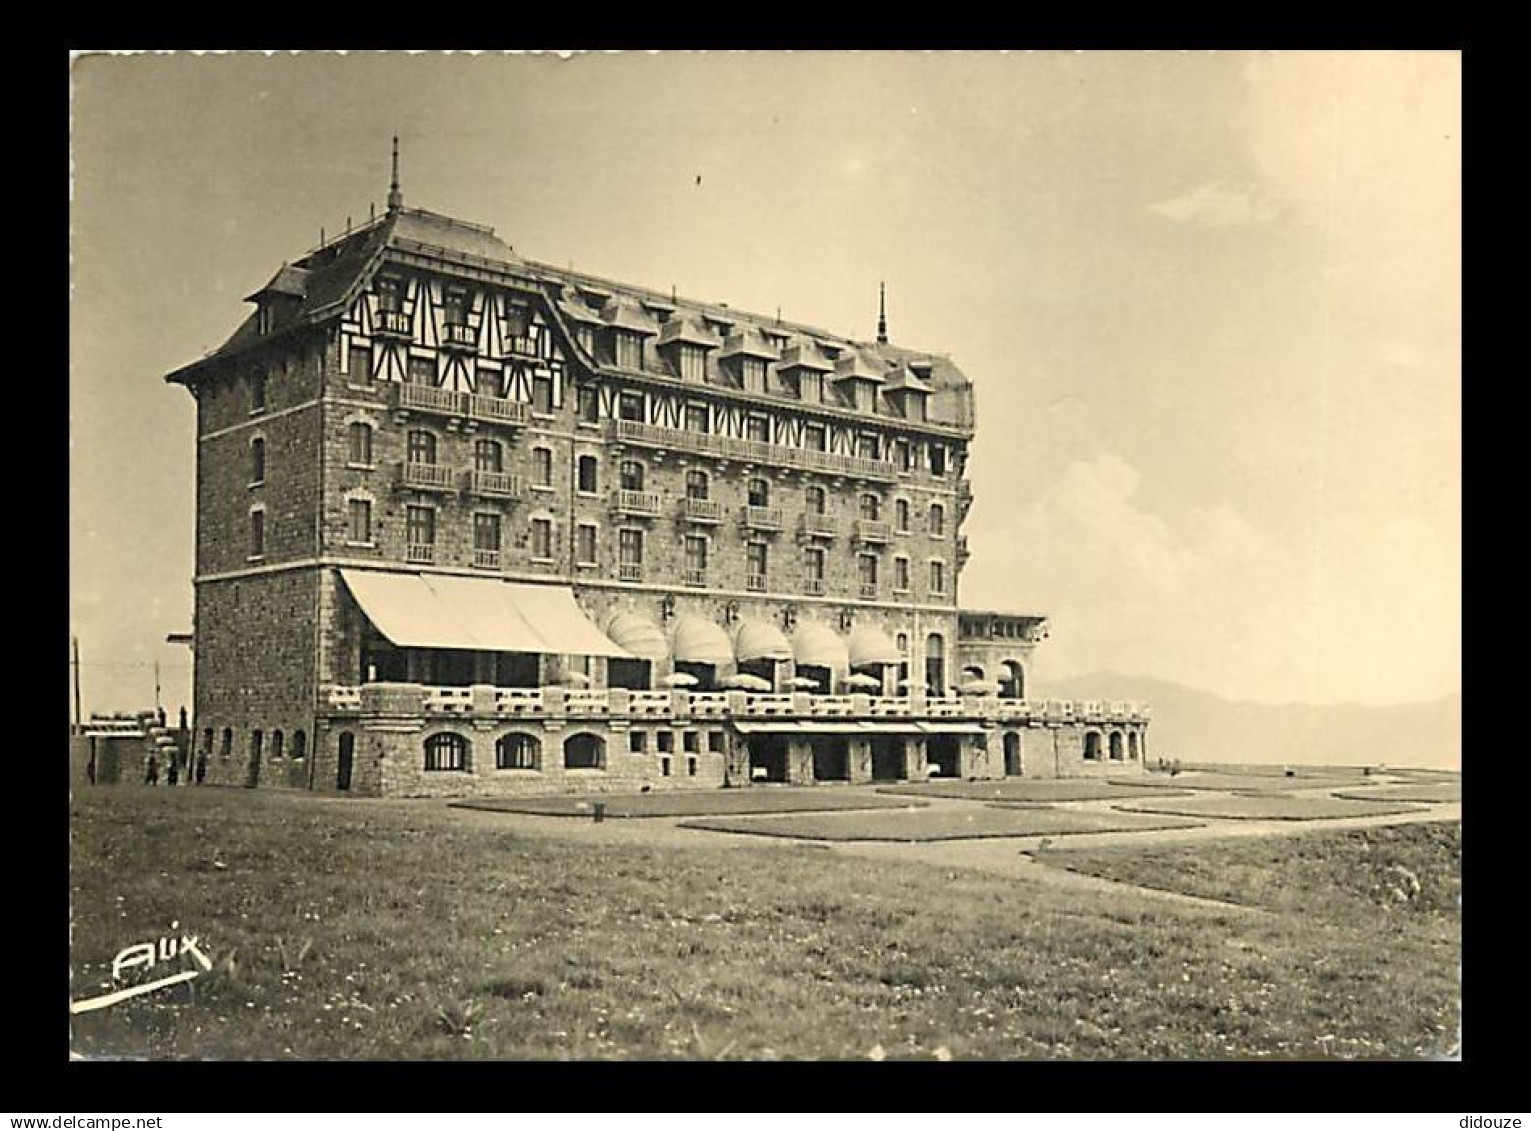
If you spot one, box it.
[681,805,1200,842]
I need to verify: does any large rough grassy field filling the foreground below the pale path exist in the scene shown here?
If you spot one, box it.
[70,788,1461,1059]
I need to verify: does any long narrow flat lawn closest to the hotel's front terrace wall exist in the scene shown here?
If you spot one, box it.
[453,785,922,820]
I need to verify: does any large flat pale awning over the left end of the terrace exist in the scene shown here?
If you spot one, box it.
[340,569,632,660]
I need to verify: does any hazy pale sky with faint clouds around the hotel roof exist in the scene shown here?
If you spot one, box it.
[70,52,1462,712]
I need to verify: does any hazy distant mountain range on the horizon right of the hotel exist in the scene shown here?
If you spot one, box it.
[1027,672,1462,770]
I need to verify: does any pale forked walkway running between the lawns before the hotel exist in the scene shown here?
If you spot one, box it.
[440,787,1462,914]
